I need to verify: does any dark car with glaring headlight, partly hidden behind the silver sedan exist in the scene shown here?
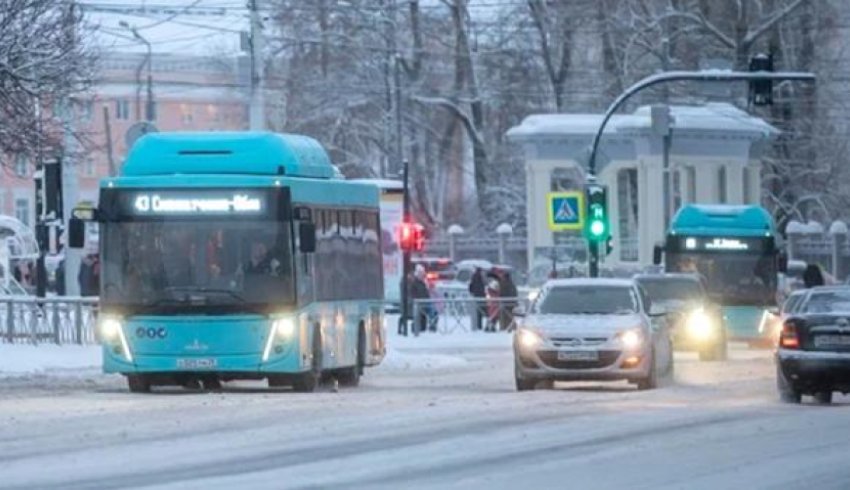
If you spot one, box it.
[634,274,727,361]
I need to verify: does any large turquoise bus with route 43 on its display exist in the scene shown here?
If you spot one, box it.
[69,132,386,392]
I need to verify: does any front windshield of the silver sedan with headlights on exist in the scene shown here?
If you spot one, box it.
[534,286,637,315]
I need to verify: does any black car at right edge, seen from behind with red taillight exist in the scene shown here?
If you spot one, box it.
[776,286,850,403]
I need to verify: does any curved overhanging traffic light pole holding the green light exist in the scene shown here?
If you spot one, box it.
[587,70,816,277]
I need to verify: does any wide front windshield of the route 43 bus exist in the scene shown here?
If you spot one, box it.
[101,220,294,311]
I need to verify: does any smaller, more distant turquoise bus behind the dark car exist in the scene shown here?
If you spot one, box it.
[654,205,781,341]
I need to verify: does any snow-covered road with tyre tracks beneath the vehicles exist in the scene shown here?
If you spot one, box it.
[0,334,850,489]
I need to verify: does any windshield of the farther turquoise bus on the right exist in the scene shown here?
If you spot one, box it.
[667,253,776,305]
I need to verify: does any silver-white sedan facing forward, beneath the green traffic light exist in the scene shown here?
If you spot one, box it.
[514,279,673,391]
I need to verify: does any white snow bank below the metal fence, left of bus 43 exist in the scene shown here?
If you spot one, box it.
[0,344,101,377]
